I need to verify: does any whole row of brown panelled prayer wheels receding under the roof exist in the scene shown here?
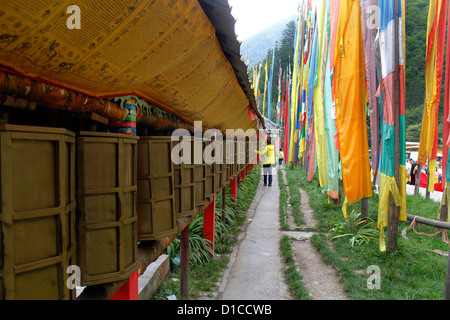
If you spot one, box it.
[0,125,251,300]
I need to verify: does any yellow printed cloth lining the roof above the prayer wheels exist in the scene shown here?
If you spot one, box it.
[0,0,260,130]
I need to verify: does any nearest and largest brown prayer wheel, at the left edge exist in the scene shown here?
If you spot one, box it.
[0,125,77,300]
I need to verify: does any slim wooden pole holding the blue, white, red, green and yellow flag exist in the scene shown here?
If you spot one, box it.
[388,1,400,252]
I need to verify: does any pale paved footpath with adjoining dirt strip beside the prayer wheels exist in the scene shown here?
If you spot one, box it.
[215,168,348,300]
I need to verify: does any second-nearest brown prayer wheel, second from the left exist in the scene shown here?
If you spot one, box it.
[77,132,139,285]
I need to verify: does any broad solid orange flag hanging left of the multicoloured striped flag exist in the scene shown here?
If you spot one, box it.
[333,1,372,203]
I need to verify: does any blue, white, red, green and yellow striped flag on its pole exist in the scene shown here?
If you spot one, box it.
[377,0,406,251]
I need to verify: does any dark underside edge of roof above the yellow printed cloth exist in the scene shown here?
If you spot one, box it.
[198,0,266,128]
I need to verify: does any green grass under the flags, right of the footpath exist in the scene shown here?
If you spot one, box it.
[286,168,449,300]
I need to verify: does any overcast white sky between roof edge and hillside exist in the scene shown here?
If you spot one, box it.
[228,0,300,41]
